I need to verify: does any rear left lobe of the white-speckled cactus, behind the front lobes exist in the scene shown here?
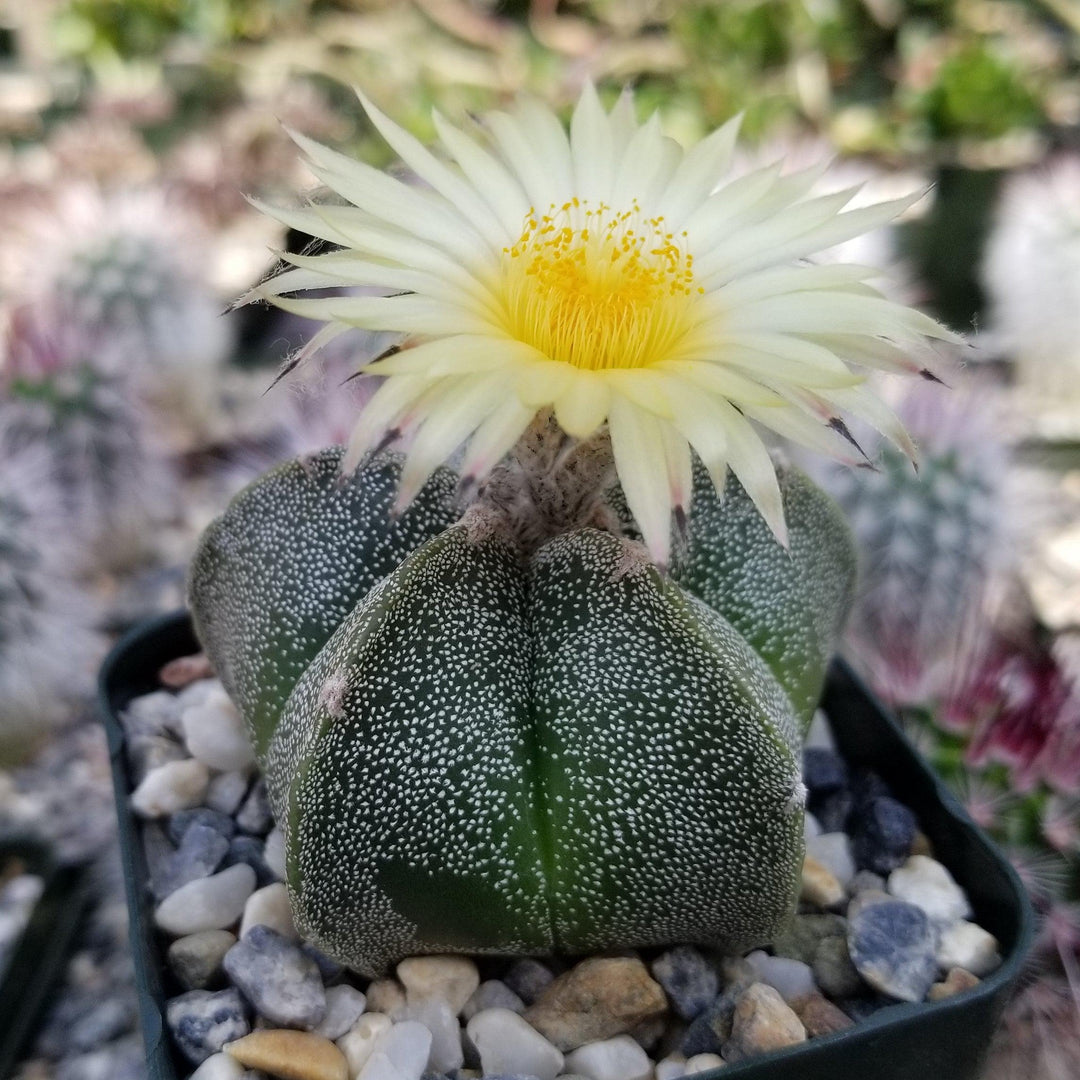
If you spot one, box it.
[189,448,457,760]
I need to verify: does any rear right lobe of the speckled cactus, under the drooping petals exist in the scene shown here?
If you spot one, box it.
[672,464,855,731]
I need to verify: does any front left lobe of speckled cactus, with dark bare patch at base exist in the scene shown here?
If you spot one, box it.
[274,526,553,975]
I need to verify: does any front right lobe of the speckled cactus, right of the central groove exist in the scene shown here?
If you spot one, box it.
[530,530,802,951]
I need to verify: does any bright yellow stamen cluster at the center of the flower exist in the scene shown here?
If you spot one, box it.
[503,199,703,370]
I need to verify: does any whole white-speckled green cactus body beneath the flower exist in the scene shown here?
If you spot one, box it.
[191,451,852,974]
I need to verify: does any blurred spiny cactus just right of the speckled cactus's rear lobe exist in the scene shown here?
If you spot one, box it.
[820,386,1010,704]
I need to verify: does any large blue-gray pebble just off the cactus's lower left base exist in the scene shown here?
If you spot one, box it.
[225,926,326,1031]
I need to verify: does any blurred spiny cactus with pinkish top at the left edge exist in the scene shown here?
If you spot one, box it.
[2,303,176,570]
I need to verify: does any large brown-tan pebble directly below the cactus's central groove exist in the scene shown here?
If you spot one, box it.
[525,957,667,1052]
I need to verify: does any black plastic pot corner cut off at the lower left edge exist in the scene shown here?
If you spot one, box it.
[0,837,90,1078]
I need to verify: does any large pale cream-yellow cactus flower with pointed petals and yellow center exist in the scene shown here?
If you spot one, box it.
[249,86,956,565]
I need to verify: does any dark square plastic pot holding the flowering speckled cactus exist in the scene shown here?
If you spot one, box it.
[99,612,1034,1080]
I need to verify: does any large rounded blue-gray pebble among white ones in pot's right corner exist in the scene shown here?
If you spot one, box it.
[848,900,937,1001]
